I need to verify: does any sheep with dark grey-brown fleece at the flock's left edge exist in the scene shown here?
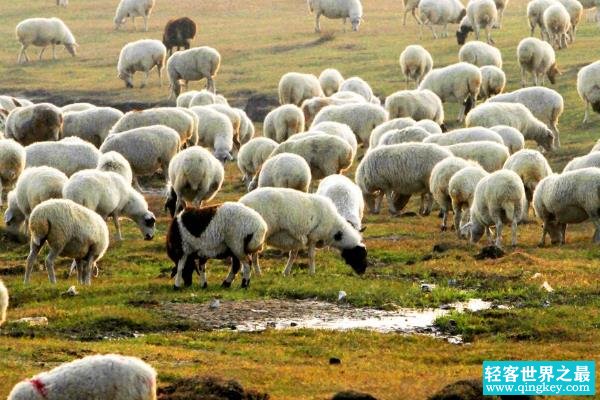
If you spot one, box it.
[4,103,63,146]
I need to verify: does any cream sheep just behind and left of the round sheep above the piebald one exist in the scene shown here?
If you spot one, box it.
[99,125,180,189]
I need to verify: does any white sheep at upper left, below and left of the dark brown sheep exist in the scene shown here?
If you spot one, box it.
[117,39,167,88]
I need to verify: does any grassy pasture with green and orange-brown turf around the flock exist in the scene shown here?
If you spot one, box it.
[0,0,600,399]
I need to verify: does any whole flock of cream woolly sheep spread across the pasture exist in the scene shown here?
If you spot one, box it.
[0,0,600,400]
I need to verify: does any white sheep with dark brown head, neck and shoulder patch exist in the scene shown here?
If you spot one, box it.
[167,202,268,289]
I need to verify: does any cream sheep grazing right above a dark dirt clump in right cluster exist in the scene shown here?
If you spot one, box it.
[461,169,527,247]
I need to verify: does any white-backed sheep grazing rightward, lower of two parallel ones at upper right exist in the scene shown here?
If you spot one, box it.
[466,102,555,151]
